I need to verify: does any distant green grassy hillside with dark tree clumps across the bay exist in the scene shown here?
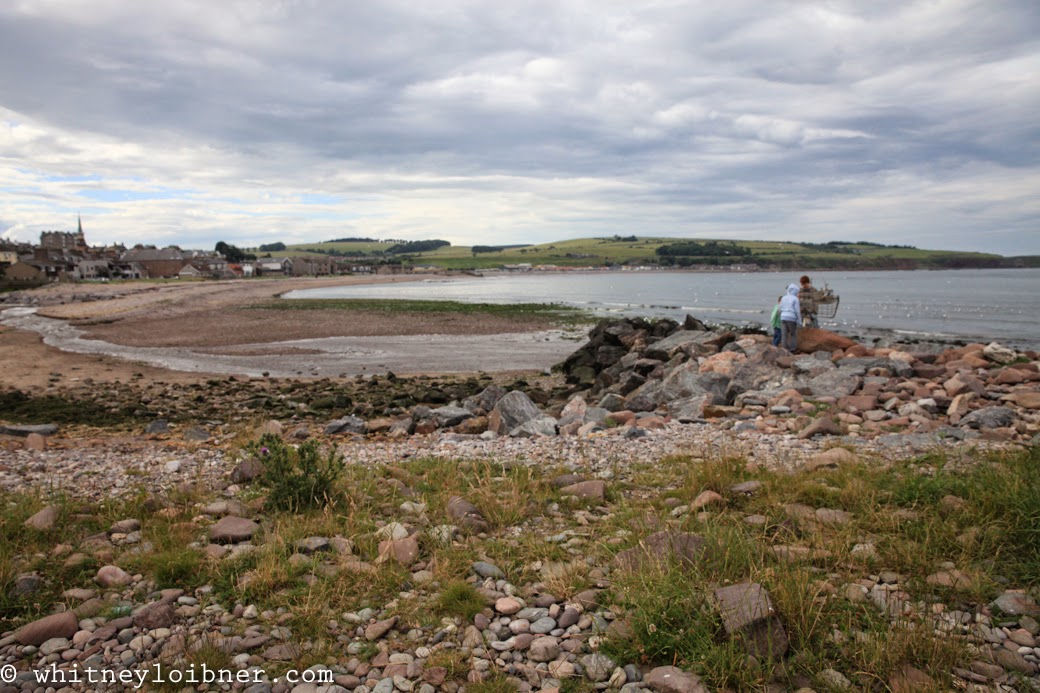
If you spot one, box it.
[276,236,1023,270]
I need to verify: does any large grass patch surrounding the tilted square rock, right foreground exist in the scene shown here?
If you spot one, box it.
[603,450,1040,691]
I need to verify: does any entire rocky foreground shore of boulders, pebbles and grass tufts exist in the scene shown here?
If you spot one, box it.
[0,319,1040,693]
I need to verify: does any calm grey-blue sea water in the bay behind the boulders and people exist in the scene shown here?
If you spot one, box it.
[286,270,1040,349]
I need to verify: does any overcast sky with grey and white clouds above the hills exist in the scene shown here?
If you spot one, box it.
[0,0,1040,255]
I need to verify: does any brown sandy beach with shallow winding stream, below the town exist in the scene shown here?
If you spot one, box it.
[0,275,579,389]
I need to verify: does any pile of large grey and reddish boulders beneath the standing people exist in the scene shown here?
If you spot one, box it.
[336,318,1040,441]
